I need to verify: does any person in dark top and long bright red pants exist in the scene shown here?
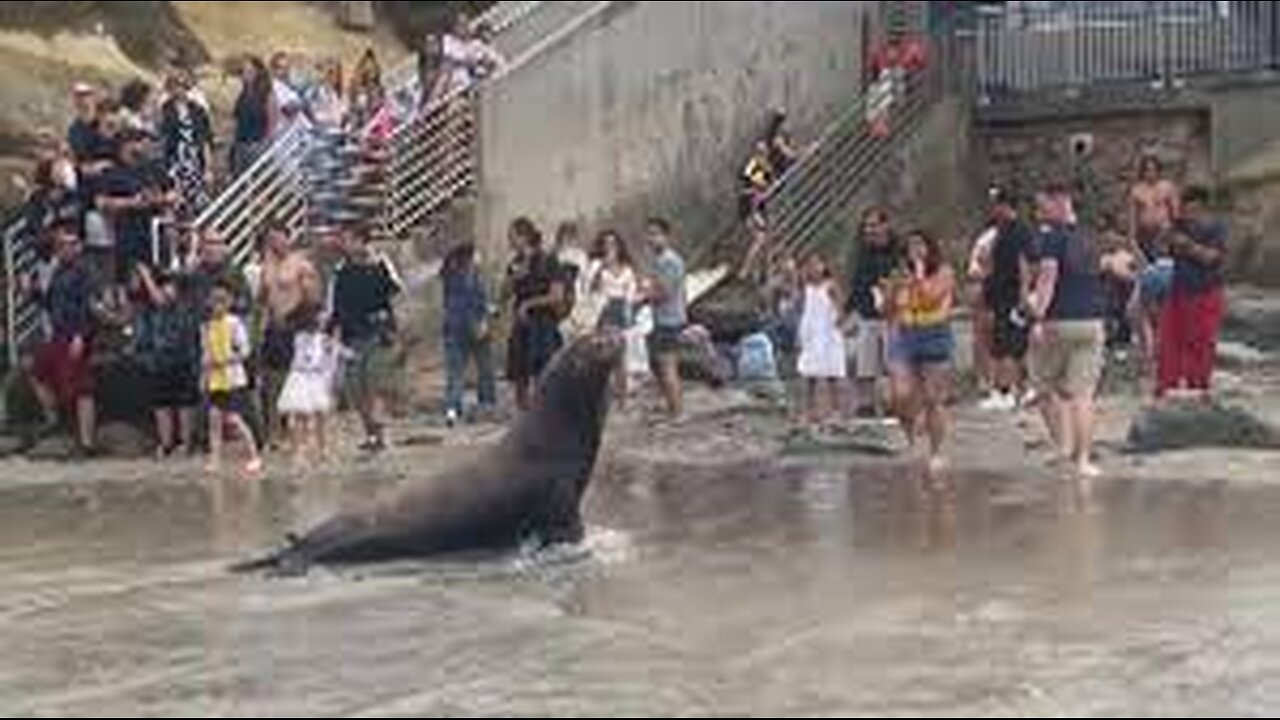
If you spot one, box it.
[1157,187,1228,397]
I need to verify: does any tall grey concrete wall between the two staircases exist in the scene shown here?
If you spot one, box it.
[479,1,878,257]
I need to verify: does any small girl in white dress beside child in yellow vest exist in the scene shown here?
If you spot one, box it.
[278,311,340,465]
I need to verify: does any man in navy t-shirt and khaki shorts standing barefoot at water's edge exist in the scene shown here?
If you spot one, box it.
[1028,186,1106,478]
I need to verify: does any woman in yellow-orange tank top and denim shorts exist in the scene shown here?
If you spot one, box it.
[882,231,956,470]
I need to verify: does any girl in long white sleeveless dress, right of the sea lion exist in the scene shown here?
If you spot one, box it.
[796,255,847,421]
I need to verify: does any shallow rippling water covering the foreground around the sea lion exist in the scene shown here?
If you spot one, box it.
[0,448,1280,717]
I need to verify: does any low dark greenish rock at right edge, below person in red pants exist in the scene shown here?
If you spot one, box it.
[1125,401,1280,454]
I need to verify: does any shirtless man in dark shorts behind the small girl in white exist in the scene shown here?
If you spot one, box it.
[259,224,324,441]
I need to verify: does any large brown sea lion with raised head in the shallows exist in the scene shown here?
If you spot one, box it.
[239,336,623,575]
